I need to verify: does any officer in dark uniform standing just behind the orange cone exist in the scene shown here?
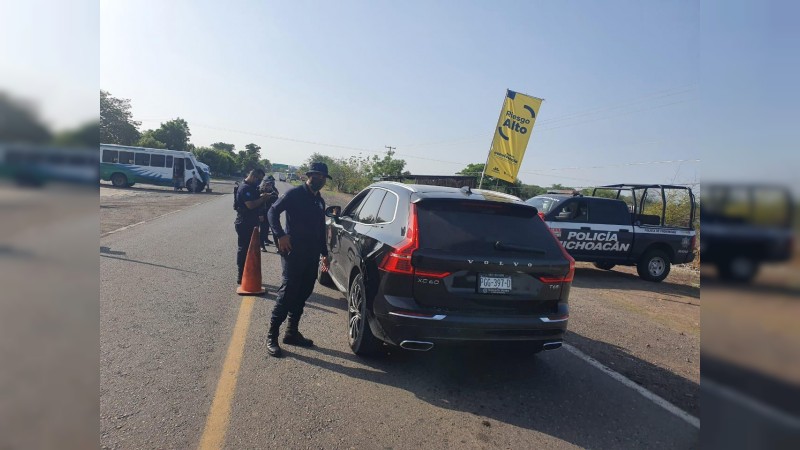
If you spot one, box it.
[234,169,269,284]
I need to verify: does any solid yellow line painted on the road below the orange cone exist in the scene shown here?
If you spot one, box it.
[198,297,255,450]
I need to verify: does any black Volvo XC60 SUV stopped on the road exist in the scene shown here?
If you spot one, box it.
[319,182,575,355]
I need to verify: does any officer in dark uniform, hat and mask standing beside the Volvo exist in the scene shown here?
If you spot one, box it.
[267,162,331,357]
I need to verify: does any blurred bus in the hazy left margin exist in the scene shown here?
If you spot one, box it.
[0,144,98,186]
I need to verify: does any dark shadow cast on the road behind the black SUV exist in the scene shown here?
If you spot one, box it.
[286,328,698,448]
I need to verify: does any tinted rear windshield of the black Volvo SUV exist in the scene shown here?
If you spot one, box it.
[417,201,560,257]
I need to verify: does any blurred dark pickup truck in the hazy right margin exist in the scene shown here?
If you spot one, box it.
[700,184,795,282]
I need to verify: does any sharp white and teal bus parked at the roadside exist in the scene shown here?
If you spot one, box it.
[100,144,210,191]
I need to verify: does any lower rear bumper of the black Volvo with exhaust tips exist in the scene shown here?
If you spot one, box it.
[374,299,568,345]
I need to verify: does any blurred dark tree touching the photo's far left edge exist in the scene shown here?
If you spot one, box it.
[0,92,51,144]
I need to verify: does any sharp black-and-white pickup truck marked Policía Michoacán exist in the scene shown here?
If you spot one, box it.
[526,184,696,282]
